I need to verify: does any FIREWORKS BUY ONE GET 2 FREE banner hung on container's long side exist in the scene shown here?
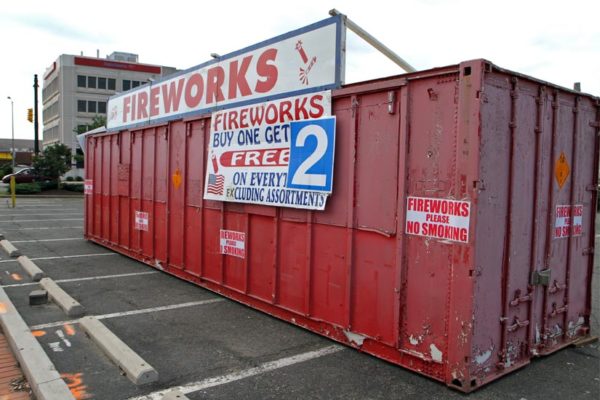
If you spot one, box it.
[204,92,335,210]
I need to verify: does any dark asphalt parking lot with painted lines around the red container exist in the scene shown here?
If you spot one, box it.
[0,198,600,400]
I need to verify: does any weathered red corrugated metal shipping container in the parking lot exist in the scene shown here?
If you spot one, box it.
[85,60,600,391]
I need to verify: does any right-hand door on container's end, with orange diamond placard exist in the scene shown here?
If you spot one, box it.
[531,93,598,354]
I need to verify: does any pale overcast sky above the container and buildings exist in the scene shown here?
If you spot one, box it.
[0,0,600,138]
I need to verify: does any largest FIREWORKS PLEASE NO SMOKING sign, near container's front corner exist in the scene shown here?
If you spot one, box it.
[406,196,471,243]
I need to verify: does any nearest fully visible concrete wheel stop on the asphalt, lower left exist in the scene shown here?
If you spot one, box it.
[79,316,158,385]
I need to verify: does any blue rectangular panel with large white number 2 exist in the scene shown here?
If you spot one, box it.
[286,117,335,193]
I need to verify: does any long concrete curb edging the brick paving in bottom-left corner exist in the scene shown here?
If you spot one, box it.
[0,287,75,400]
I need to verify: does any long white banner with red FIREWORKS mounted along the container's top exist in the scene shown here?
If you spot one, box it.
[107,16,343,131]
